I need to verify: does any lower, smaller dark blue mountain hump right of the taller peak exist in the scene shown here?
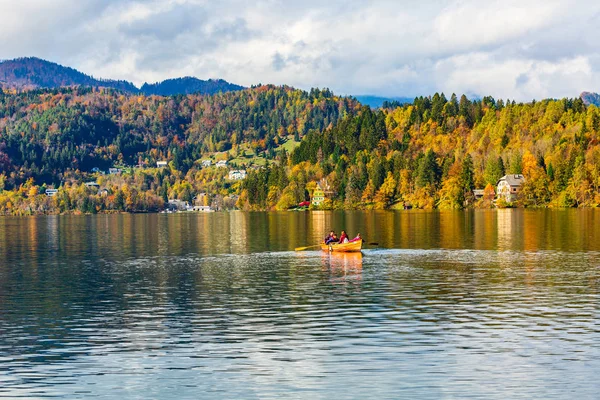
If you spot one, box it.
[140,76,244,96]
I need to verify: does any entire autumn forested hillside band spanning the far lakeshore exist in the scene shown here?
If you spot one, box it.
[0,86,600,213]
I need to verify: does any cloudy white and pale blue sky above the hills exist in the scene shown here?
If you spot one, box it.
[0,0,600,101]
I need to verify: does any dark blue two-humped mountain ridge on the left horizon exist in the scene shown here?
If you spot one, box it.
[0,57,244,96]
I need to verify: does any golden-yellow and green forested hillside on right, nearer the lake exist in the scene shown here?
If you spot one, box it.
[240,94,600,209]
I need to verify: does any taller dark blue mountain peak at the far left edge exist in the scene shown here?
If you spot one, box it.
[0,57,138,93]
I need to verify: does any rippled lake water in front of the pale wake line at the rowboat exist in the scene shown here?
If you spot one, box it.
[0,233,600,398]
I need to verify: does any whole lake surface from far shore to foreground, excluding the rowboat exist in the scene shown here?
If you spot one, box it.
[0,210,600,399]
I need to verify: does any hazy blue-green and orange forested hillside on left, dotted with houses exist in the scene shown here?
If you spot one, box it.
[0,86,360,212]
